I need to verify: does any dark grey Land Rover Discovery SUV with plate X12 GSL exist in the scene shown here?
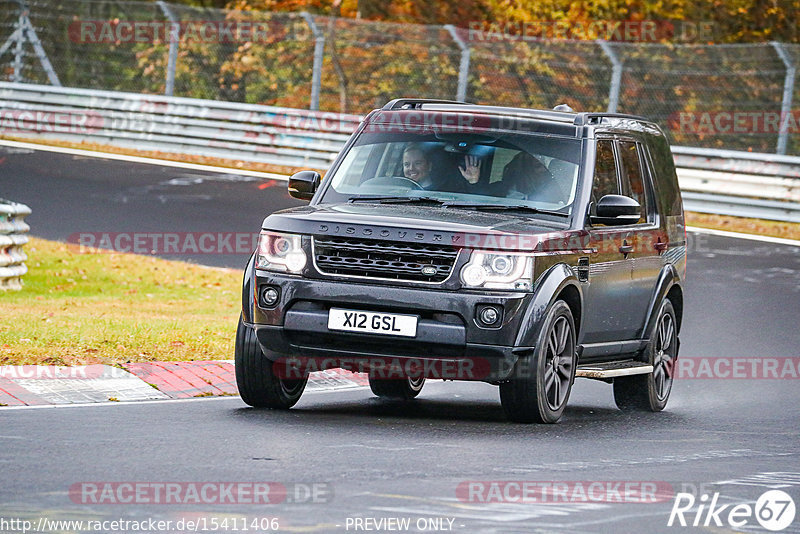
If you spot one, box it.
[235,99,686,423]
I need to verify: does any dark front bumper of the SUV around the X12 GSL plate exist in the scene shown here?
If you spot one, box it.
[248,271,533,381]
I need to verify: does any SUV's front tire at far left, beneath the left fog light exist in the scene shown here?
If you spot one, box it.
[234,317,308,410]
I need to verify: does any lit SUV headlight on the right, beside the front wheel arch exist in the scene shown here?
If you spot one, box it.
[461,250,533,291]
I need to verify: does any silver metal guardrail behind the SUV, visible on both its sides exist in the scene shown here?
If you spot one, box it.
[0,82,800,222]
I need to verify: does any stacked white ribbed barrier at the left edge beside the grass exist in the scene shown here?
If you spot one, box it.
[0,198,31,290]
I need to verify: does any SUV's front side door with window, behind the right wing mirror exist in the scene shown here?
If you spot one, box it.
[582,137,635,348]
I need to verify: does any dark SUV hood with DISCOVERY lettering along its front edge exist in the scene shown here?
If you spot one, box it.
[262,203,570,249]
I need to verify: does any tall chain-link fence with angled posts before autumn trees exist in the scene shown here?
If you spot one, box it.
[0,0,800,155]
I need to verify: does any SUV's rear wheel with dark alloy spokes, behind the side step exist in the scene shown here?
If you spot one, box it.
[614,299,678,412]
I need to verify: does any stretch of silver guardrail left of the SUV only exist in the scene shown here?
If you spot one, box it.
[0,82,361,169]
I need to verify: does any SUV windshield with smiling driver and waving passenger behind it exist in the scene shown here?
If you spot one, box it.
[320,126,581,215]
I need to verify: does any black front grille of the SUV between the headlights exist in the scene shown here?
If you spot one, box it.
[314,237,458,282]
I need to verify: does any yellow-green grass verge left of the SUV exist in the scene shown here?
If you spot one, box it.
[0,238,242,365]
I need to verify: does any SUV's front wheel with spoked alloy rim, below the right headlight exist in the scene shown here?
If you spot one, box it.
[500,300,577,423]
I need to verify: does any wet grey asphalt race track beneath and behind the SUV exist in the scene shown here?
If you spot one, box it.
[0,143,800,532]
